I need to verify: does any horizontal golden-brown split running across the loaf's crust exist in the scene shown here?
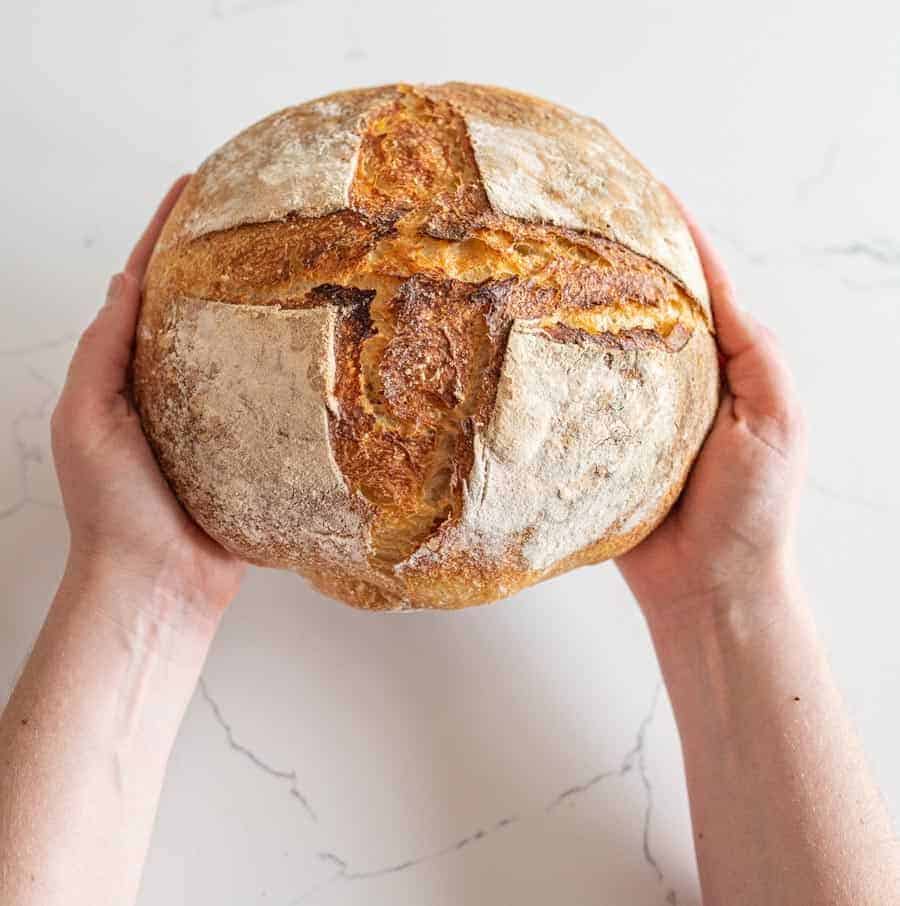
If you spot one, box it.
[149,182,703,321]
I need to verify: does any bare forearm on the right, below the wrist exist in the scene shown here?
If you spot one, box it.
[651,581,900,906]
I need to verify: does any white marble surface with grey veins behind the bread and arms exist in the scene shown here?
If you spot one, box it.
[0,0,900,906]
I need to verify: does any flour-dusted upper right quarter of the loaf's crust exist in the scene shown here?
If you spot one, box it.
[426,82,710,316]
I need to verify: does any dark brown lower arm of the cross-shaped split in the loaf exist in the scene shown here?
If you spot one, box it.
[331,275,502,569]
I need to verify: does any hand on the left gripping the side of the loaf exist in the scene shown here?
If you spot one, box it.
[51,176,244,619]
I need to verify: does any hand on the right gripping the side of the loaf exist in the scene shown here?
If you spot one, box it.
[617,194,806,622]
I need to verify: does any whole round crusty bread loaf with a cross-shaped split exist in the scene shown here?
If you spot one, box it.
[134,83,719,610]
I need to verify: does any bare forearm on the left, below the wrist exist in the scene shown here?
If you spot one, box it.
[0,571,214,906]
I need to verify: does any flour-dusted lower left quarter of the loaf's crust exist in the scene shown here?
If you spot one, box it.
[134,293,371,584]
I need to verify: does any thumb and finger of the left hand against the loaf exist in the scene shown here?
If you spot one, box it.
[63,176,188,412]
